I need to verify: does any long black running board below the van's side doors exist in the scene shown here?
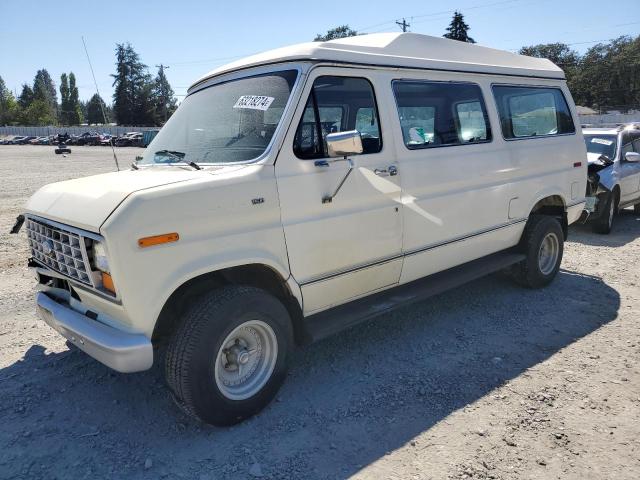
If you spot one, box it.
[304,250,526,343]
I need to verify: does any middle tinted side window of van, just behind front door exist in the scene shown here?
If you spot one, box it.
[393,80,491,149]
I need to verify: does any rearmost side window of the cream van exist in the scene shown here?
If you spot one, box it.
[493,85,576,139]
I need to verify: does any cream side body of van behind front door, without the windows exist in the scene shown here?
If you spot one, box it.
[387,70,586,283]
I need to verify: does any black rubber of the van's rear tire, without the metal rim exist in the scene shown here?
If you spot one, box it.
[511,215,564,288]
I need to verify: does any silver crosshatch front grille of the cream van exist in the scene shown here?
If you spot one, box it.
[26,217,96,288]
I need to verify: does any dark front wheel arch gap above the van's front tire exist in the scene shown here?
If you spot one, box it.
[151,263,306,344]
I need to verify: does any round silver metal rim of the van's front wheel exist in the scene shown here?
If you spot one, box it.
[215,320,278,400]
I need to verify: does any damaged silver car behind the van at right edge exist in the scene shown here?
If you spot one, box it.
[582,123,640,234]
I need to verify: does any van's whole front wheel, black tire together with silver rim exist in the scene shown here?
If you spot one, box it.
[165,286,293,426]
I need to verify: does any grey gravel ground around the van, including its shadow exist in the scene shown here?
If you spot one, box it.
[0,146,640,480]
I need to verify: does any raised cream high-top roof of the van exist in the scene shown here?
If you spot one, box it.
[192,33,565,87]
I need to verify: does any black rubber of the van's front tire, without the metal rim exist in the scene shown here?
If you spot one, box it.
[165,286,293,426]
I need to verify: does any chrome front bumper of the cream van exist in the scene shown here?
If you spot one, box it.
[36,292,153,373]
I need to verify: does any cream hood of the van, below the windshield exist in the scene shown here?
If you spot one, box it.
[26,166,242,232]
